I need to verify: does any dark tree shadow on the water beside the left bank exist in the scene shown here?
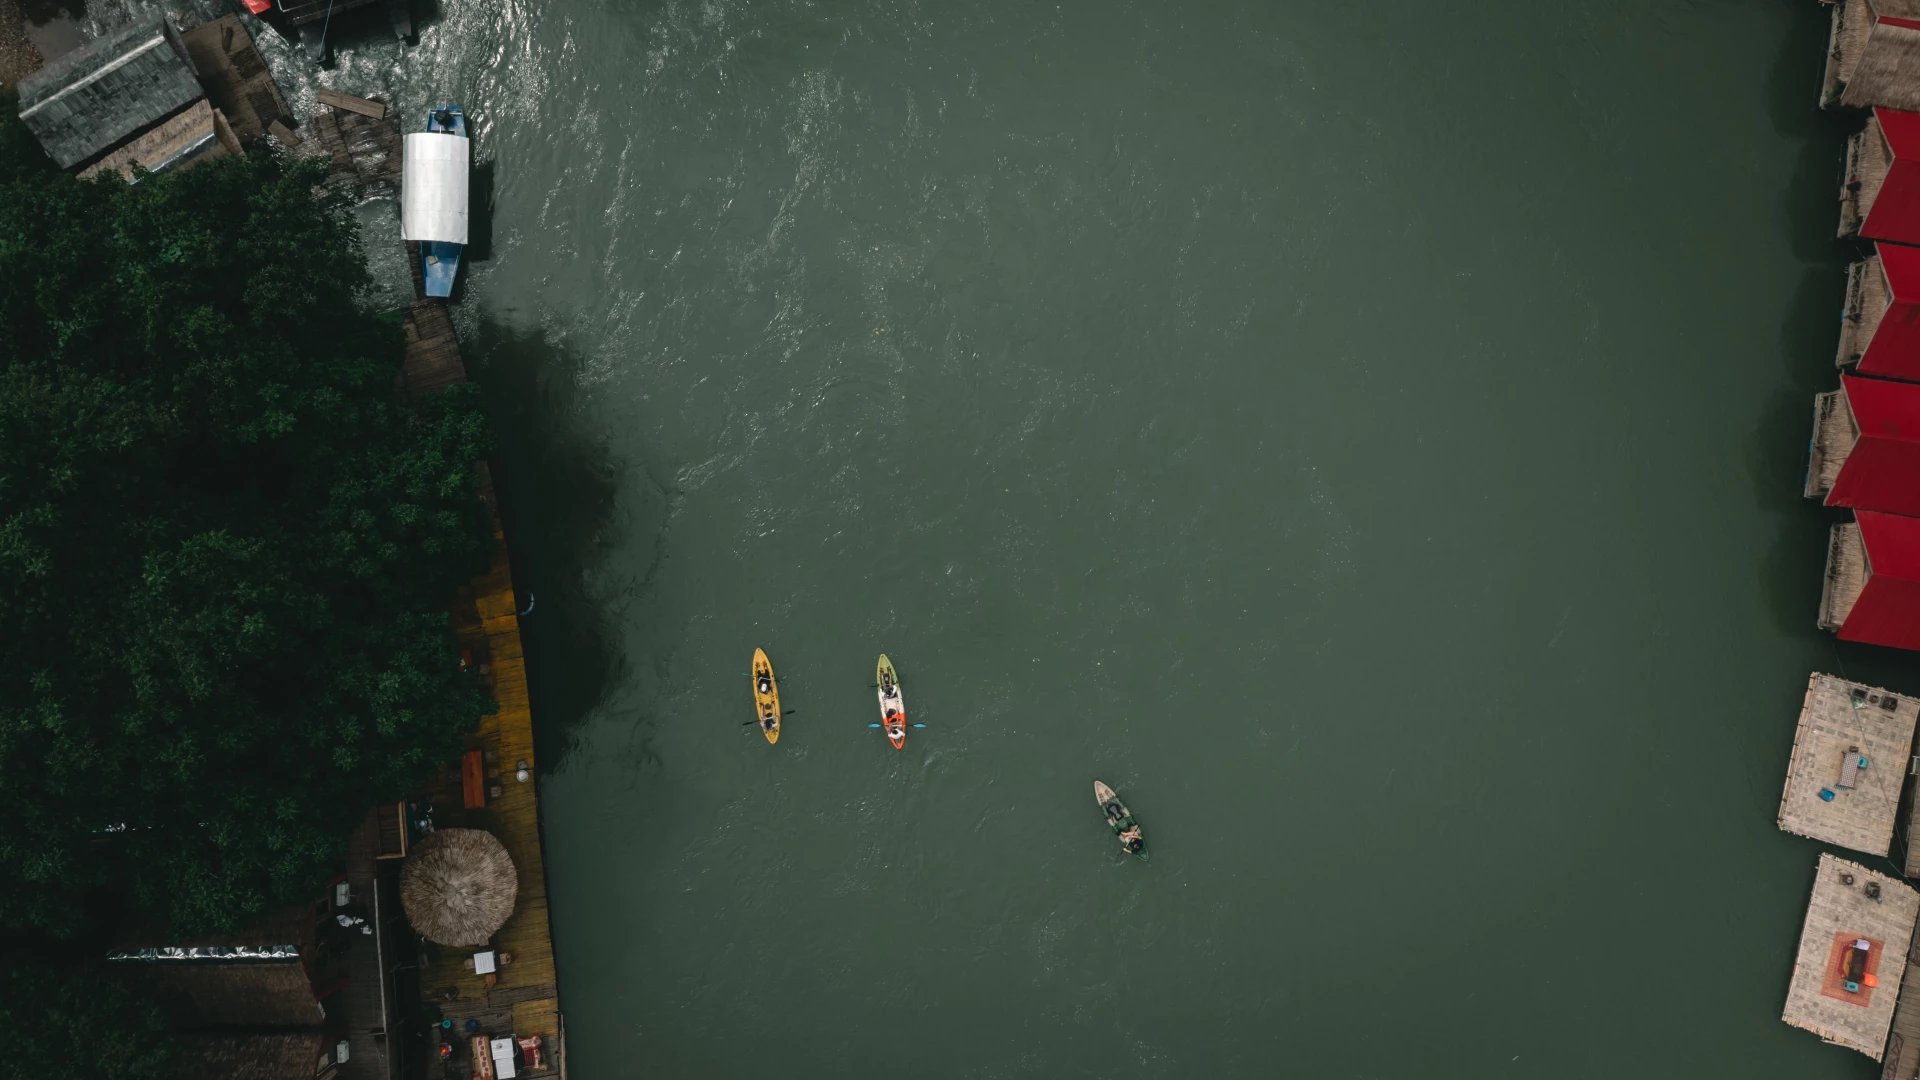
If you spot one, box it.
[468,319,620,773]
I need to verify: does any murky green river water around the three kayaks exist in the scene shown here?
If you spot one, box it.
[161,0,1920,1080]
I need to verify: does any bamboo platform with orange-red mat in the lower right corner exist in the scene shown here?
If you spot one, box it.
[1780,855,1920,1061]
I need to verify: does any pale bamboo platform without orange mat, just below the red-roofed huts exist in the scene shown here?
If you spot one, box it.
[1776,673,1920,855]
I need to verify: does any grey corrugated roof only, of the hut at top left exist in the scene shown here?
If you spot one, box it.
[19,19,204,169]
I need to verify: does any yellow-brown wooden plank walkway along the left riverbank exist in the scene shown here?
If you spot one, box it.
[401,300,566,1080]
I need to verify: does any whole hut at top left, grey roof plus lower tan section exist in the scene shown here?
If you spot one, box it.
[19,19,240,177]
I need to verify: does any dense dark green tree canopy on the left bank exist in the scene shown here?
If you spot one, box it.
[0,138,492,932]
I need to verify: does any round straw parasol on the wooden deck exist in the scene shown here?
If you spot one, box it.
[399,828,520,945]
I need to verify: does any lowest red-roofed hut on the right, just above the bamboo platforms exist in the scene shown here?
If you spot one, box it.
[1820,509,1920,650]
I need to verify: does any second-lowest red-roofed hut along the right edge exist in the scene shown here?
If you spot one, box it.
[1805,375,1920,517]
